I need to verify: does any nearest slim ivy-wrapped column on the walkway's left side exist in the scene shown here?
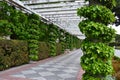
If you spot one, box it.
[28,14,40,60]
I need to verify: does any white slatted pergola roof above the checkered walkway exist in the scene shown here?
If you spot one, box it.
[8,0,88,39]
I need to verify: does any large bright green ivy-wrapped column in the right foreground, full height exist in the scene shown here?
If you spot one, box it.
[77,0,115,80]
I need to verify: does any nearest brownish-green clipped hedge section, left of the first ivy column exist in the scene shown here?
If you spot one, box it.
[0,40,29,70]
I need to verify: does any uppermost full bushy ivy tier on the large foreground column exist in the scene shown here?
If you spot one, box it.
[77,5,115,24]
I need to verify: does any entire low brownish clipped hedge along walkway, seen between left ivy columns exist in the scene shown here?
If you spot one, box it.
[0,40,75,71]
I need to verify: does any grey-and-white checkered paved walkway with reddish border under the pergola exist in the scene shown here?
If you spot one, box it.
[0,49,82,80]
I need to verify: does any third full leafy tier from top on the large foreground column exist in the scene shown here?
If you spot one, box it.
[81,40,114,60]
